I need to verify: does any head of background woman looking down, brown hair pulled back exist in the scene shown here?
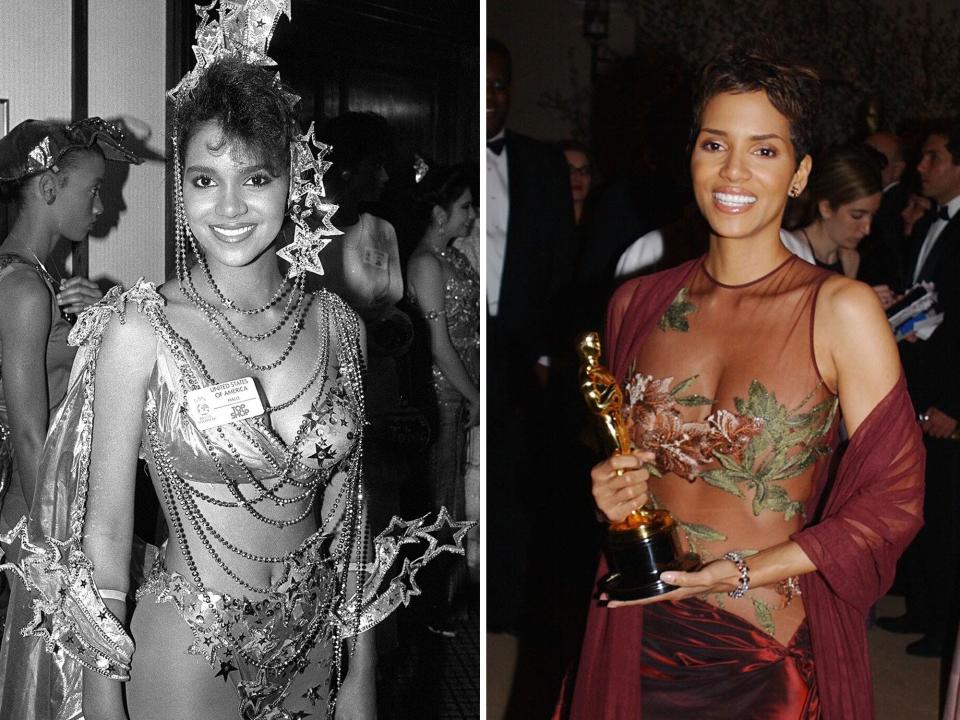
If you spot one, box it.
[785,146,883,278]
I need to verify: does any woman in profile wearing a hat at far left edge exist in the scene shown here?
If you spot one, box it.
[0,118,138,544]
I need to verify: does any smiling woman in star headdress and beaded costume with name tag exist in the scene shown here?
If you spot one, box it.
[2,1,470,720]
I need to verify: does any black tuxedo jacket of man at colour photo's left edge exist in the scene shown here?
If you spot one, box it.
[496,131,575,366]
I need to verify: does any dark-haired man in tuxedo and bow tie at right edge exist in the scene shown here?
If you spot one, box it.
[880,120,960,657]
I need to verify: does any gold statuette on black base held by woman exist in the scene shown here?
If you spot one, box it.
[578,332,700,600]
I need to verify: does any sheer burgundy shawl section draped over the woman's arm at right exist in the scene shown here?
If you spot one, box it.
[793,375,925,718]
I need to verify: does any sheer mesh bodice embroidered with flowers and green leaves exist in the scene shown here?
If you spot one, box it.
[627,257,837,642]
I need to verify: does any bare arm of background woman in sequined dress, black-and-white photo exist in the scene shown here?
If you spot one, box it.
[407,254,480,422]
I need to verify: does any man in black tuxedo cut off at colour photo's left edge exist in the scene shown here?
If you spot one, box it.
[484,38,586,720]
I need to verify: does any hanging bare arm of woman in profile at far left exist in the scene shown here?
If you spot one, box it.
[0,268,51,510]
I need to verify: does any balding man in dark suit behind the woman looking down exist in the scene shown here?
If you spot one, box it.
[857,132,912,294]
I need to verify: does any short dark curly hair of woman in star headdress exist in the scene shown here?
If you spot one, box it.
[176,57,298,177]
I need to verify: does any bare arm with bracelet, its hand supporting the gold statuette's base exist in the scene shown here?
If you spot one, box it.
[609,276,900,607]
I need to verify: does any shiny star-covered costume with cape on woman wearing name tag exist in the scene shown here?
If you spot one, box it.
[0,282,456,720]
